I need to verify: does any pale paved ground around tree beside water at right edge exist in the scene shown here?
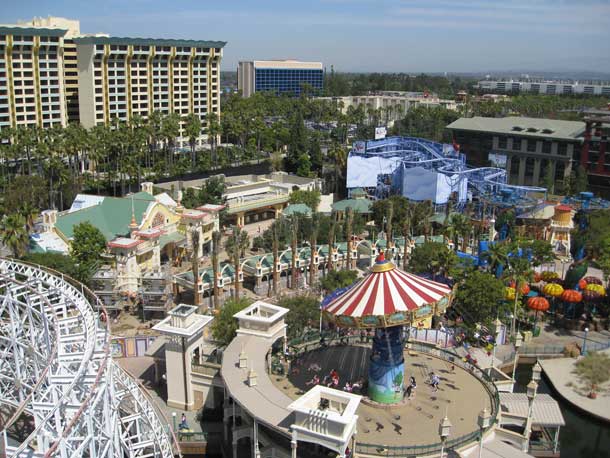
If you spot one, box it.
[539,350,610,422]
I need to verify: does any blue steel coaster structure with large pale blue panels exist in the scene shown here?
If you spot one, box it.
[347,137,546,208]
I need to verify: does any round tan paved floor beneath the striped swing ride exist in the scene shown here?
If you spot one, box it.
[271,345,491,448]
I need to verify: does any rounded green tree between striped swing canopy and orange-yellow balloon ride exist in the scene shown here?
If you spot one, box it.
[454,270,504,326]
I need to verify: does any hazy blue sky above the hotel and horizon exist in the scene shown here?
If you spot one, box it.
[0,0,610,73]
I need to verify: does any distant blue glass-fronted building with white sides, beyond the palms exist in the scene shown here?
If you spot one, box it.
[237,60,324,97]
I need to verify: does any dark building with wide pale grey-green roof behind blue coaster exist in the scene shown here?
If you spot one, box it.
[447,116,586,186]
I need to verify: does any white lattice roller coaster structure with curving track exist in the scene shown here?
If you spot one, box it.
[0,259,179,458]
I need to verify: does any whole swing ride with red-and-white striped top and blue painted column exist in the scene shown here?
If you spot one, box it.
[323,253,452,404]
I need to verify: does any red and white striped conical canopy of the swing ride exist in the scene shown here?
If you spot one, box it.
[325,256,451,319]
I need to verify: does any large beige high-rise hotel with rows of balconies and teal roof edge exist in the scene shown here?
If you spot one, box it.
[0,17,226,146]
